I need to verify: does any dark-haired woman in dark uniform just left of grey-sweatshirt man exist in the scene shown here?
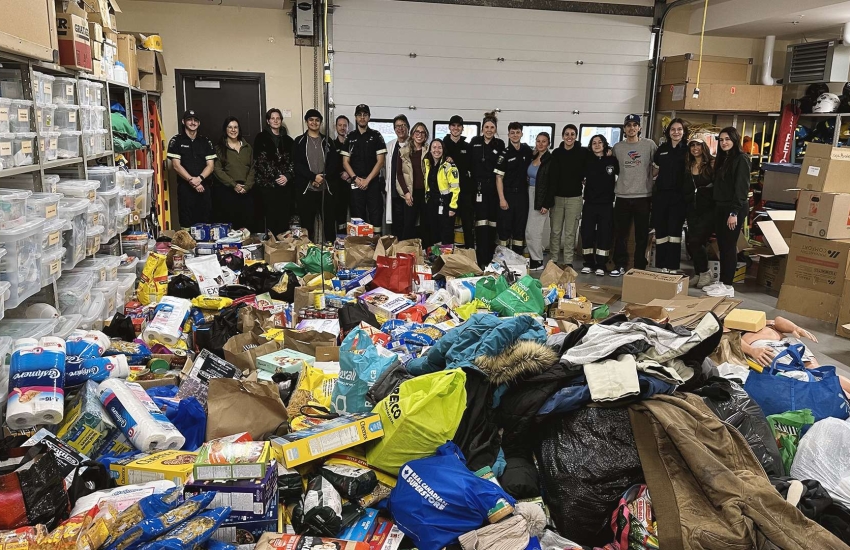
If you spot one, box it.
[581,134,620,277]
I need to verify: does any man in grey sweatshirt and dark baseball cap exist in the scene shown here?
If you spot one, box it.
[609,114,658,277]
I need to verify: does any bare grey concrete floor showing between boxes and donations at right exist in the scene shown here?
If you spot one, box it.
[564,263,850,377]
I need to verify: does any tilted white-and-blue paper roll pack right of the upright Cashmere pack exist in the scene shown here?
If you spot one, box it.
[98,378,186,452]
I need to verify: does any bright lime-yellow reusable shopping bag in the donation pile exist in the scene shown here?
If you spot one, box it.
[366,369,466,476]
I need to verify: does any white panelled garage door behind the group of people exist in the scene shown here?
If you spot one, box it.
[331,0,651,143]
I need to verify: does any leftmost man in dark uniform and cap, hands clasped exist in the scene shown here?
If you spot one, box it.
[167,109,216,227]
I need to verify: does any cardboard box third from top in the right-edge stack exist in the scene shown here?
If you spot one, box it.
[782,233,850,296]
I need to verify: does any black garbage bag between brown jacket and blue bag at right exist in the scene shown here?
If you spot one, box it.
[694,378,784,477]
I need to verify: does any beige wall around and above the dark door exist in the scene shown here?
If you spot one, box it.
[118,0,321,136]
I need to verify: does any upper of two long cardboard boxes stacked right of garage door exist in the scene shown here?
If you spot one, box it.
[660,53,753,86]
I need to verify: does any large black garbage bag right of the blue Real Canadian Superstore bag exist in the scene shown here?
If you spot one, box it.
[536,407,645,547]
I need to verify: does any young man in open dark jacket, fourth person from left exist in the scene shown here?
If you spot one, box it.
[292,109,339,243]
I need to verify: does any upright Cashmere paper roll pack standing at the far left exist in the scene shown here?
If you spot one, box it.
[6,336,65,429]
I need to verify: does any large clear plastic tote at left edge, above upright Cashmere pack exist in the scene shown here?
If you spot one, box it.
[0,219,44,308]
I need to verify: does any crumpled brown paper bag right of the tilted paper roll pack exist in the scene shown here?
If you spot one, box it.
[206,378,289,441]
